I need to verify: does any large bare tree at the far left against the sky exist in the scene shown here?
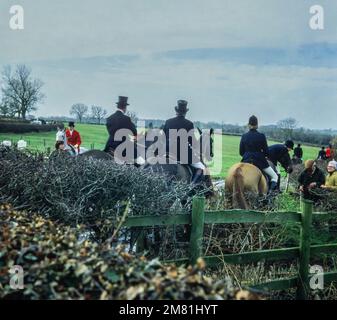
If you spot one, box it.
[1,65,45,119]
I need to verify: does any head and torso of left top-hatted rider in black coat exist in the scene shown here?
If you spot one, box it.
[104,96,137,160]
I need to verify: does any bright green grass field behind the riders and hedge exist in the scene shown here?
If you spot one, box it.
[0,124,319,177]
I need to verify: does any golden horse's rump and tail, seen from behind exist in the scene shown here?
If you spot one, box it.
[225,162,268,209]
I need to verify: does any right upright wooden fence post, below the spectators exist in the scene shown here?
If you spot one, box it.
[297,200,313,300]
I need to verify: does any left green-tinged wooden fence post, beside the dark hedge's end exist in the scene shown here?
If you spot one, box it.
[190,197,205,265]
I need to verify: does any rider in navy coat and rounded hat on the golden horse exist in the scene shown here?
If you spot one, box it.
[240,116,278,191]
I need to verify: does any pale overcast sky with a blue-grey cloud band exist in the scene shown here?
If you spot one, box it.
[0,0,337,129]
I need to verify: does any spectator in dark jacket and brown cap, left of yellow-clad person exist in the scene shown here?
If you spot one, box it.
[298,160,325,202]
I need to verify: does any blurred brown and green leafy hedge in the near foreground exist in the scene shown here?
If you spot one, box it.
[0,205,258,300]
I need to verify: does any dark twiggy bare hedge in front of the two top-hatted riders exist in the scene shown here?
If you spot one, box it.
[0,148,192,225]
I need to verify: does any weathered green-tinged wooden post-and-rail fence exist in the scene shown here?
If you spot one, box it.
[124,197,337,299]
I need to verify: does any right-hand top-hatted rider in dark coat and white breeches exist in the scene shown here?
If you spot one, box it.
[163,100,206,184]
